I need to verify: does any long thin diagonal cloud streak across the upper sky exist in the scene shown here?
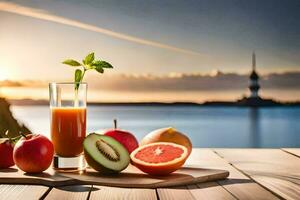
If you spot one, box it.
[0,2,206,57]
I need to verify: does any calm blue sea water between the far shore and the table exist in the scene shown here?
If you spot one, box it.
[11,105,300,148]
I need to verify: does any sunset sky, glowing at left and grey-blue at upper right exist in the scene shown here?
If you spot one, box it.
[0,0,300,101]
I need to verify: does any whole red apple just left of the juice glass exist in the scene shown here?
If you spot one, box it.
[13,134,54,173]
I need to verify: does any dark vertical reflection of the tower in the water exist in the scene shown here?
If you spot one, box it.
[249,108,261,148]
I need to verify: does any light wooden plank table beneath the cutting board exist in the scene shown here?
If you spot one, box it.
[0,148,300,200]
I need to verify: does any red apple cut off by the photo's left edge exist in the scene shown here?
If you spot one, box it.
[0,138,15,169]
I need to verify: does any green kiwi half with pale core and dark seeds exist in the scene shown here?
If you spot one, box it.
[83,133,130,174]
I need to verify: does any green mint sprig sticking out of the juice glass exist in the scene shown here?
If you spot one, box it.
[62,52,113,90]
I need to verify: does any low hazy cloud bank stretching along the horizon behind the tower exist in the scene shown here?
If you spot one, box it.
[0,71,300,92]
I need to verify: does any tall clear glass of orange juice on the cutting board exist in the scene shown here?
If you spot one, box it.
[49,83,87,171]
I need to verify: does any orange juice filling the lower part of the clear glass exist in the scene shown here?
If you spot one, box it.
[50,107,86,157]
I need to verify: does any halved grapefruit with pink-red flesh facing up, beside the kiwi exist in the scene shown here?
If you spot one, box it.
[130,142,188,175]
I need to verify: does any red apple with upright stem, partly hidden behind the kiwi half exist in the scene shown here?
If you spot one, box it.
[104,120,139,154]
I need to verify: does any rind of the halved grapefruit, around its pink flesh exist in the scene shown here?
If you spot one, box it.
[130,142,189,175]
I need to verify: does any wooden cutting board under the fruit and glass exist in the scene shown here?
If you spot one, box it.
[0,165,229,188]
